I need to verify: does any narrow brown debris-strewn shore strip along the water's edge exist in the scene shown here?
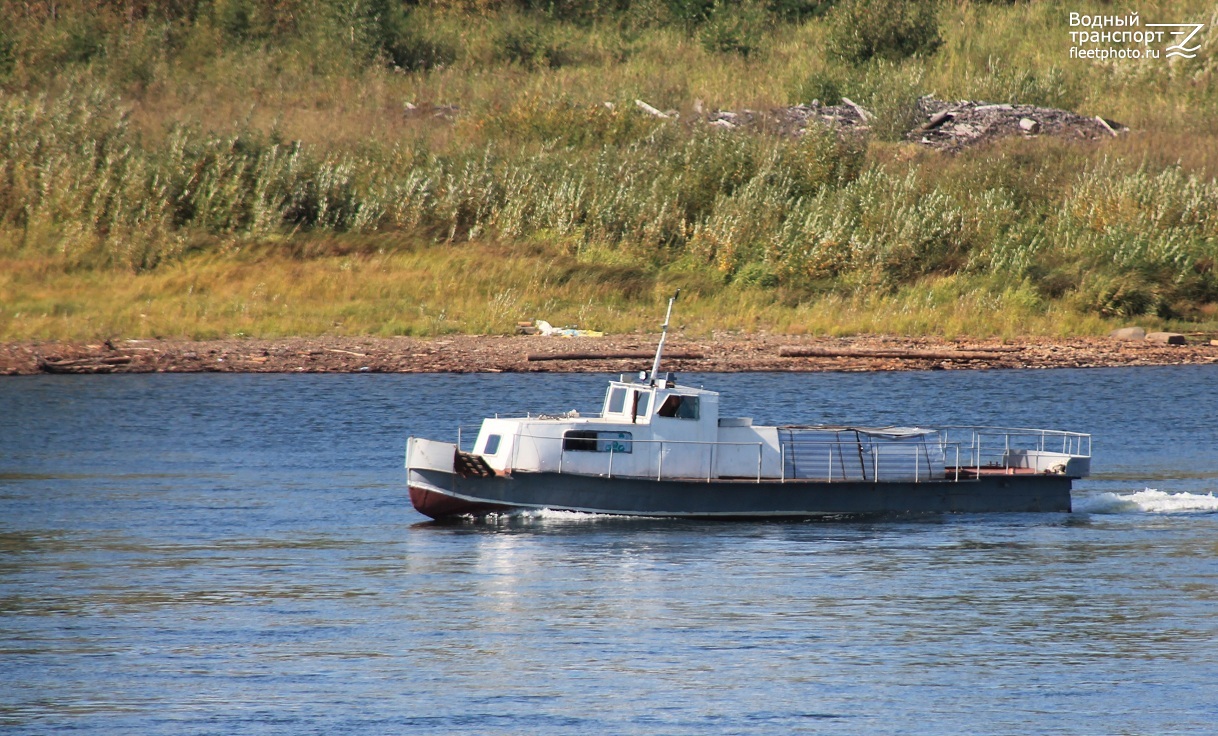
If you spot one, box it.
[0,334,1218,375]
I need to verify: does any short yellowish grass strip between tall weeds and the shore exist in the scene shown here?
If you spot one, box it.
[0,242,1203,341]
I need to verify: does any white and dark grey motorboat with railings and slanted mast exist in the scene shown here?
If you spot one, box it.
[406,292,1091,519]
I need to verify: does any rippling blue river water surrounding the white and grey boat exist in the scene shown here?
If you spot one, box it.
[0,366,1218,736]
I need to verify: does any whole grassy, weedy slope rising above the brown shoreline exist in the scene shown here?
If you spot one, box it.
[0,1,1218,340]
